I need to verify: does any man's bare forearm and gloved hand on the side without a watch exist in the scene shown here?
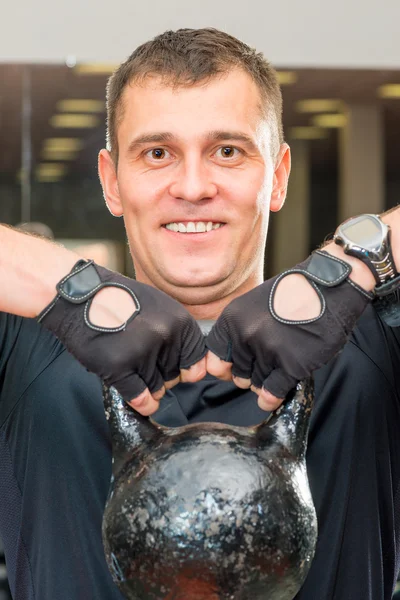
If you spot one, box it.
[0,226,205,414]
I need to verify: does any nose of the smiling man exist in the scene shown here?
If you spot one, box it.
[169,156,217,202]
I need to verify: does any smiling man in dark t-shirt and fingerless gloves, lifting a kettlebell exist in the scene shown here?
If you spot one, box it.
[0,29,400,600]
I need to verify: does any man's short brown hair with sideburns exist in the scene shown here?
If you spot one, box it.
[107,28,283,162]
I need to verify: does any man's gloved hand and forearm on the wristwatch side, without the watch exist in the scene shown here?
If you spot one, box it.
[207,207,400,410]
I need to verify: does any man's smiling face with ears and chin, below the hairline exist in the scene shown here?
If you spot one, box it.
[99,70,290,318]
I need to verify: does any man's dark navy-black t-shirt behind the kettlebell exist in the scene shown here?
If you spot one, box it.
[0,308,400,600]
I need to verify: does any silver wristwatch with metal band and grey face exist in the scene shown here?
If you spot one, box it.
[333,214,400,296]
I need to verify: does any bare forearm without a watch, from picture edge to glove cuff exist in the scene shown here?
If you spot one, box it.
[0,225,81,317]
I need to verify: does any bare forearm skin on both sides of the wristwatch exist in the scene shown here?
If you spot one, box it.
[324,207,400,291]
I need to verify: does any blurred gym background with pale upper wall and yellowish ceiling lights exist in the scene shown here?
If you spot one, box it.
[0,0,400,600]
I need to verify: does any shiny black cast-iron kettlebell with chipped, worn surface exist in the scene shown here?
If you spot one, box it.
[103,322,317,600]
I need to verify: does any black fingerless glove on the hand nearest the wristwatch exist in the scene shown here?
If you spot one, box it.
[206,251,373,398]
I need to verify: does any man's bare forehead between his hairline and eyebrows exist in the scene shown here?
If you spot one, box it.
[118,69,264,144]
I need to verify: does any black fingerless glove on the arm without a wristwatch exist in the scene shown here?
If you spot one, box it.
[38,260,206,400]
